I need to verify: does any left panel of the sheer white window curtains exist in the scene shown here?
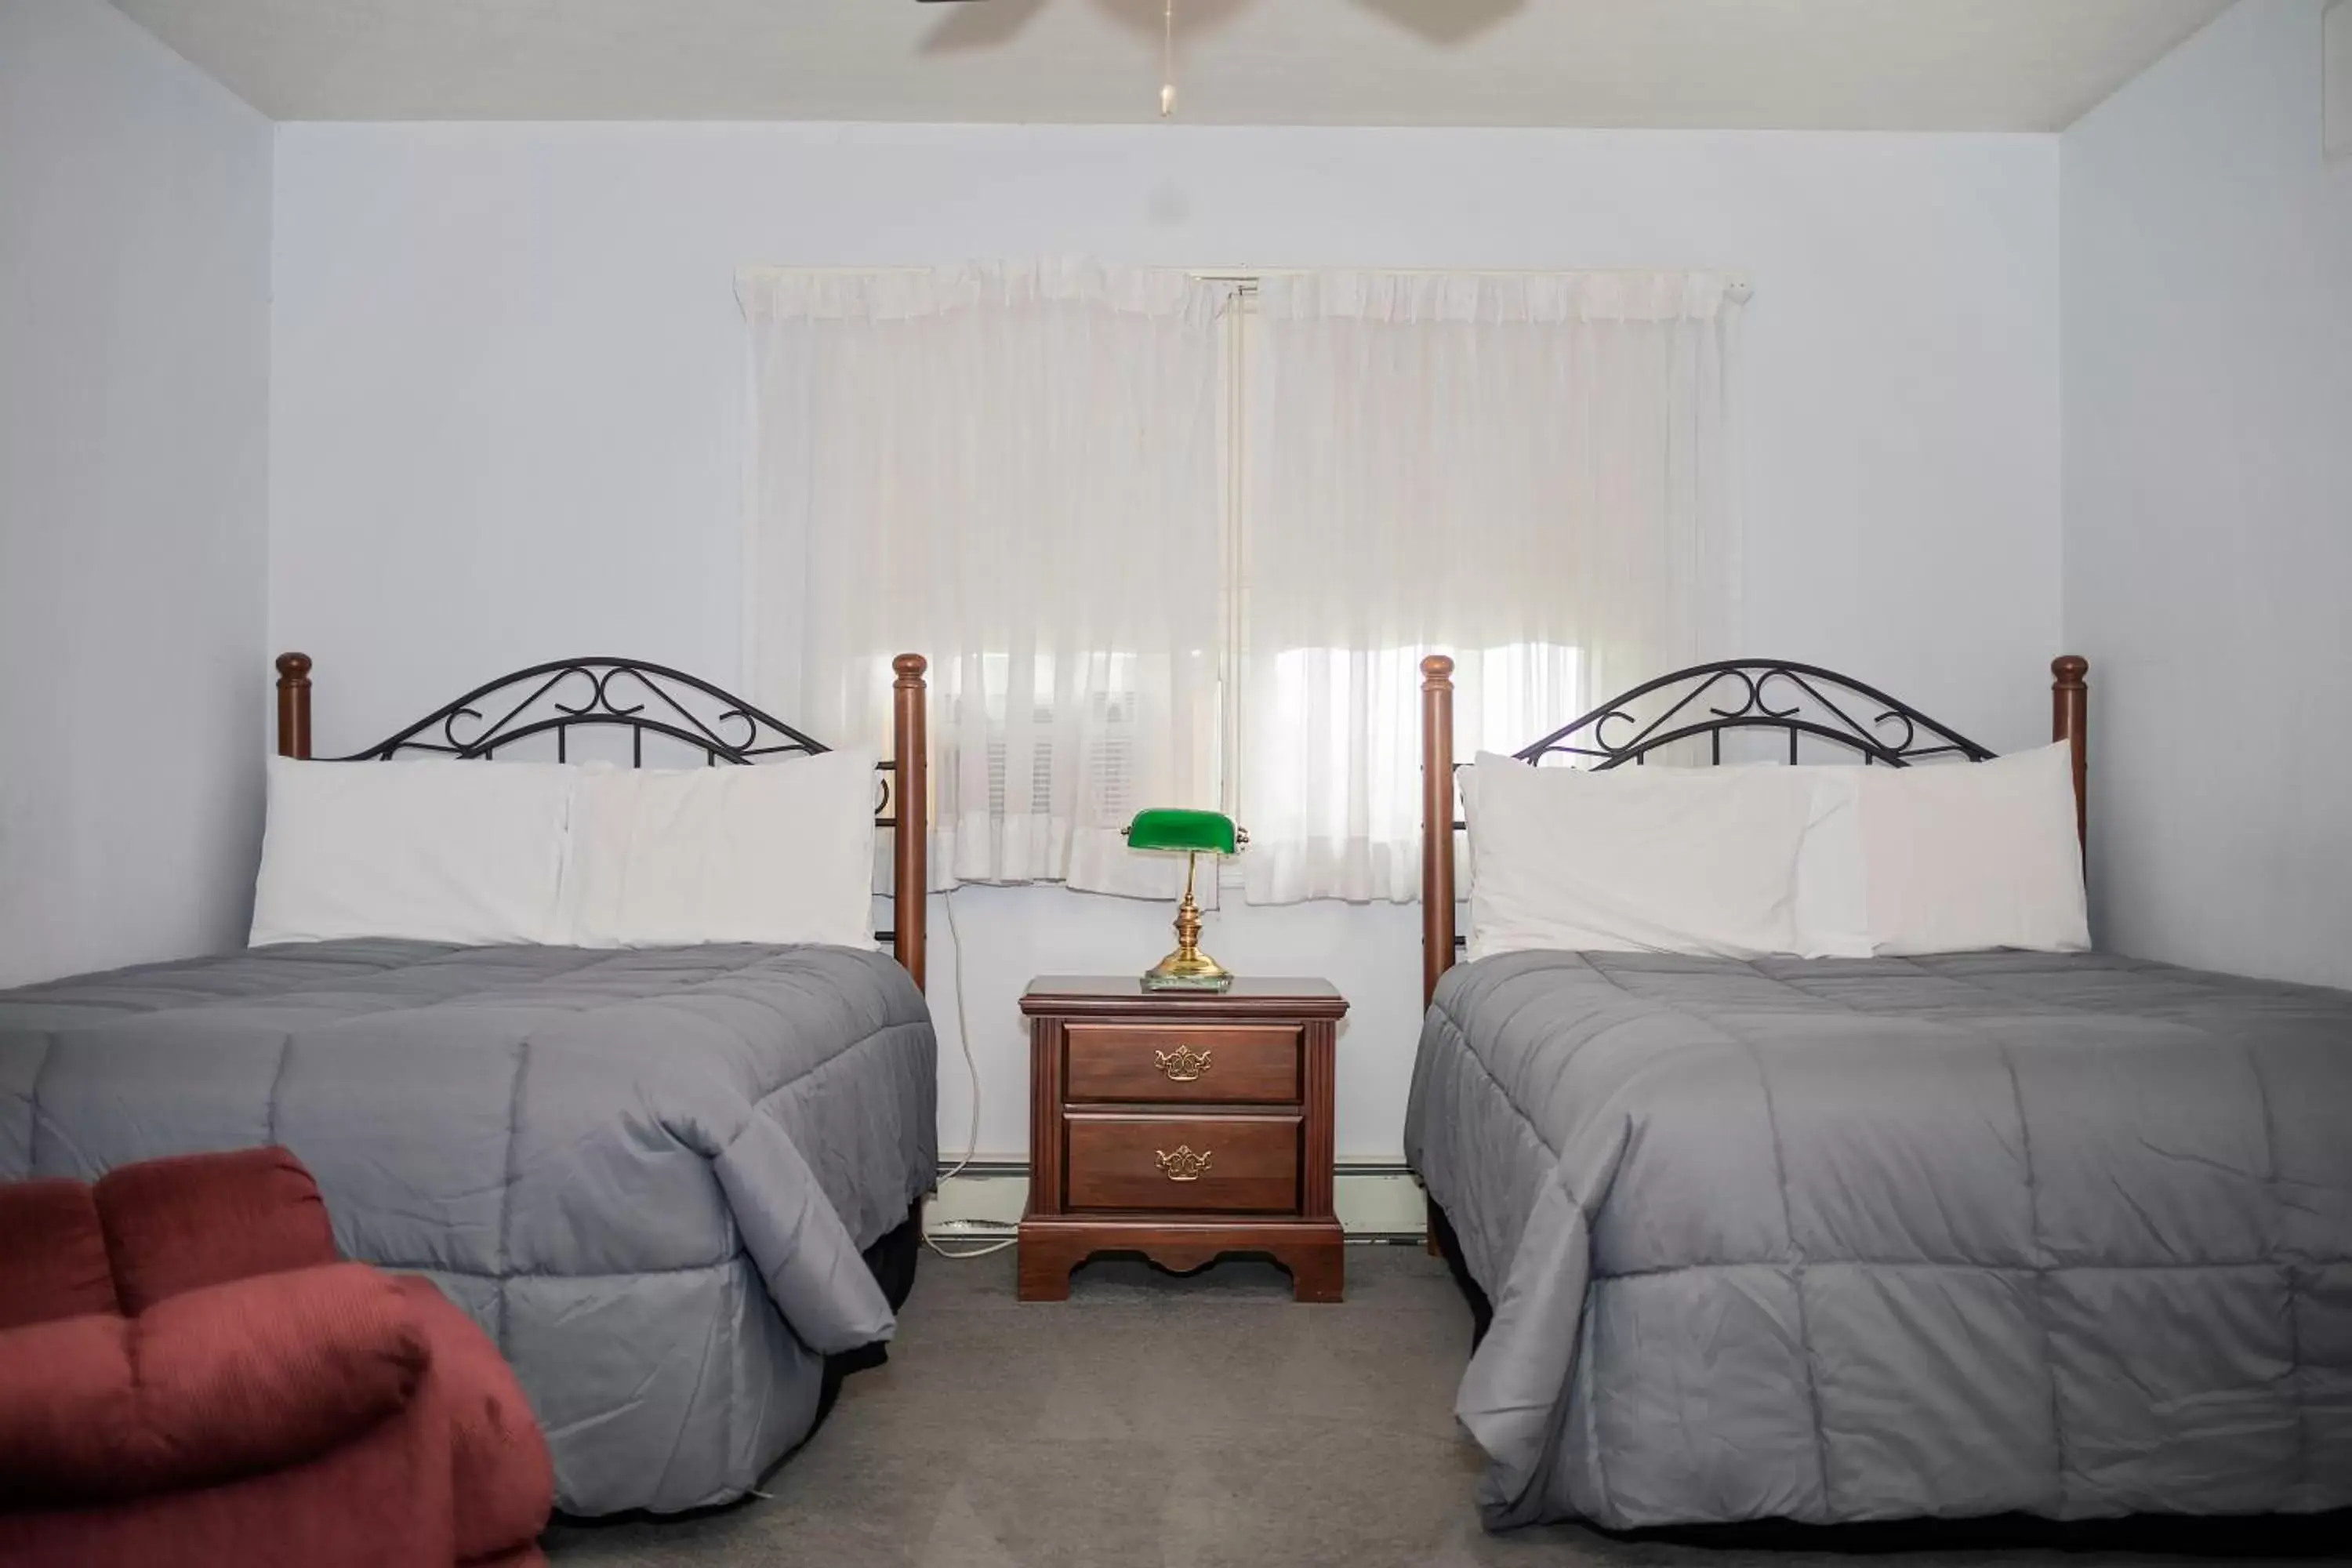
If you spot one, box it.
[736,261,1228,895]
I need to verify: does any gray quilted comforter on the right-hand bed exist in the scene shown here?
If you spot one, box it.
[1406,952,2352,1528]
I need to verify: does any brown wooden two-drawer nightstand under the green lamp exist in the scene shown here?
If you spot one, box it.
[1021,975,1348,1302]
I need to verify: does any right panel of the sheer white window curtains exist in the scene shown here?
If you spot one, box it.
[1242,273,1743,902]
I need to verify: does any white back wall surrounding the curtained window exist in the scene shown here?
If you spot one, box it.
[270,125,2060,1156]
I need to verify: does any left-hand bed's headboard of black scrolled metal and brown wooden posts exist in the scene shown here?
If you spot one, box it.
[278,654,931,989]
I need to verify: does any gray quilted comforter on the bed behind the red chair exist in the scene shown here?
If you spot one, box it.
[0,940,936,1514]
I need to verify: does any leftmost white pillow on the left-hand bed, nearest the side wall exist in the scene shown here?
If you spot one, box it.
[252,757,572,947]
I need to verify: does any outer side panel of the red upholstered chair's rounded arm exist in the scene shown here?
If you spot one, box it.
[400,1274,555,1561]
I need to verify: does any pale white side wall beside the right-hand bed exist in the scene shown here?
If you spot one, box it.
[2063,0,2352,985]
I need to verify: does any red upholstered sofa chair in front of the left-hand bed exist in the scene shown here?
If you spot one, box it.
[0,1149,555,1568]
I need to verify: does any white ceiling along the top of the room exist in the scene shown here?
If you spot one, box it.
[115,0,2227,132]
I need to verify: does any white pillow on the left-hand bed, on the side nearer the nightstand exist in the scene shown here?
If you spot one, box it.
[557,750,875,947]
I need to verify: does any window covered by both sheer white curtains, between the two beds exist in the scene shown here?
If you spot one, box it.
[739,261,1738,902]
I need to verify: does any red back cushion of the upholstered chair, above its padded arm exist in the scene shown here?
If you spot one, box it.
[96,1147,336,1316]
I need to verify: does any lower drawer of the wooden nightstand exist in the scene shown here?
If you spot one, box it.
[1065,1116,1298,1213]
